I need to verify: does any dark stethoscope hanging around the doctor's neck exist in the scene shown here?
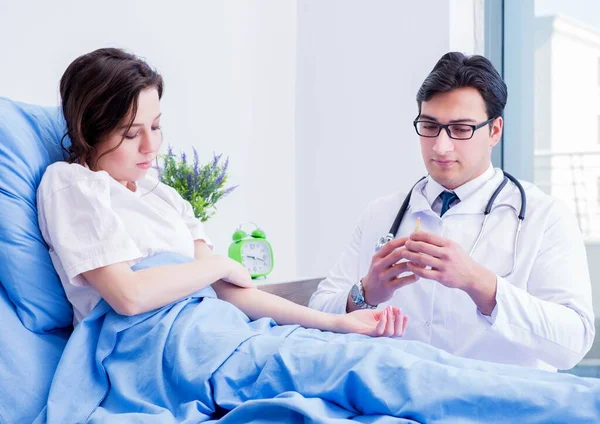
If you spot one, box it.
[375,172,527,277]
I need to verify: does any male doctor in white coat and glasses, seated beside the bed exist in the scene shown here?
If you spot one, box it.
[310,53,595,371]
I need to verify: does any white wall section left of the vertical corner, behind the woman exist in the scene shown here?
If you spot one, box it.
[0,0,296,273]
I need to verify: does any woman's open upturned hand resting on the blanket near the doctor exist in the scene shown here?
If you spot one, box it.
[335,306,408,337]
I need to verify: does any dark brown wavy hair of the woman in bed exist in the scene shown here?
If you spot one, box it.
[60,48,163,169]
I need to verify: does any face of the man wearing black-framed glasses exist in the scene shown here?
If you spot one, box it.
[418,87,503,190]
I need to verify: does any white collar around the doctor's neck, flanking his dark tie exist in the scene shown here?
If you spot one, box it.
[408,167,504,217]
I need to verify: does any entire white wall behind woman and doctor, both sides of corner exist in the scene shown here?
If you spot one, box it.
[0,0,482,277]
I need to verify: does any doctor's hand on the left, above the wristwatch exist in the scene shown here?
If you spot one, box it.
[362,237,419,305]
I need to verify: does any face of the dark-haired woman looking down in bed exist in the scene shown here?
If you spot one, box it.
[96,88,162,189]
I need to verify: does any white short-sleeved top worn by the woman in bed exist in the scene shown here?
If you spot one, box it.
[37,162,211,325]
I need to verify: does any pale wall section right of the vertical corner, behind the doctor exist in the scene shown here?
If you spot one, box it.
[296,0,482,276]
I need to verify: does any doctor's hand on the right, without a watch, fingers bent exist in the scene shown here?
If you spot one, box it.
[401,231,496,315]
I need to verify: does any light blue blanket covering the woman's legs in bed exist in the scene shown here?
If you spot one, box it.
[37,255,600,424]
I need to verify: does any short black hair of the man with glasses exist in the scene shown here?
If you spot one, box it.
[417,52,508,121]
